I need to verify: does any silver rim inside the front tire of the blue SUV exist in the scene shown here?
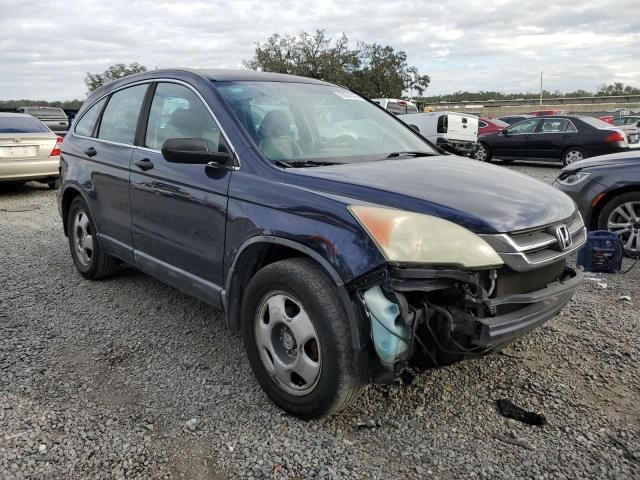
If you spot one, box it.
[254,291,322,396]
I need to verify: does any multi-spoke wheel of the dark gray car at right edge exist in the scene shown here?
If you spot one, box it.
[598,192,640,258]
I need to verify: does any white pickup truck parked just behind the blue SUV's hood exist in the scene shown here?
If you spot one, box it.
[398,112,478,155]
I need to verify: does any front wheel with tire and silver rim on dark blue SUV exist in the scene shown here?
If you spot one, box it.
[242,258,364,419]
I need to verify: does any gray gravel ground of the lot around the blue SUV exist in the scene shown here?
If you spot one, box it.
[0,165,640,479]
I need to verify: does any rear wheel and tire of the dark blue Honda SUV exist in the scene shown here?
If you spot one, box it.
[67,197,118,280]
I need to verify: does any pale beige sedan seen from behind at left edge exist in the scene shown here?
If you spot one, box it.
[0,113,62,189]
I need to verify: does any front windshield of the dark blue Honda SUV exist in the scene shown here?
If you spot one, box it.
[215,82,437,164]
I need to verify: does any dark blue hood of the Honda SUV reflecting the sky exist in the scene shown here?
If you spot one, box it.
[287,155,575,233]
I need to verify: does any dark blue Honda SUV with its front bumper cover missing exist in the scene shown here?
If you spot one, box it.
[59,70,585,418]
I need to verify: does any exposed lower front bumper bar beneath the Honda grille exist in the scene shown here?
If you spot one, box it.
[471,268,583,347]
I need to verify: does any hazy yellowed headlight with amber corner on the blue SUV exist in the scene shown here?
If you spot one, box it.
[349,205,503,268]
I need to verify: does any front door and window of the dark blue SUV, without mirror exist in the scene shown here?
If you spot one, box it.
[131,82,233,300]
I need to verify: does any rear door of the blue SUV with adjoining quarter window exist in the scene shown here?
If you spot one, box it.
[73,83,148,260]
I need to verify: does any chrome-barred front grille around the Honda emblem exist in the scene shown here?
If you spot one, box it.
[480,212,587,272]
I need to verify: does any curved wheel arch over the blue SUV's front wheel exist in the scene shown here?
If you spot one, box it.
[222,235,367,350]
